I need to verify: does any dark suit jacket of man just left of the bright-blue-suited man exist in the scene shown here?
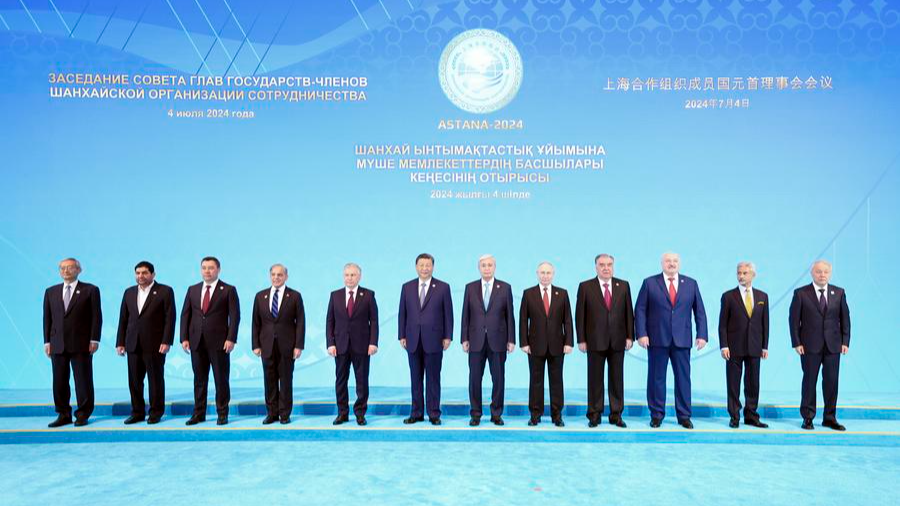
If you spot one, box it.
[575,277,634,351]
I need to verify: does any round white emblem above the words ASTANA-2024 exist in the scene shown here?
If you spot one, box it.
[438,29,522,113]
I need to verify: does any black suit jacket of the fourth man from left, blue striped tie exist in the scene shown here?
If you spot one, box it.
[250,285,306,358]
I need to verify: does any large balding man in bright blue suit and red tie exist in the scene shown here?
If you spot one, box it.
[634,253,708,429]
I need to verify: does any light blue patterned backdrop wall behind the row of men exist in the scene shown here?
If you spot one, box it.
[0,0,900,401]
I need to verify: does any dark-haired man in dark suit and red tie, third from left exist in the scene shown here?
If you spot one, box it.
[181,257,241,425]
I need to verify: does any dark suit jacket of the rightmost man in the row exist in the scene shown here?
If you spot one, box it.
[789,283,850,353]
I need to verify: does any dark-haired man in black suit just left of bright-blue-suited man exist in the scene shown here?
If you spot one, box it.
[575,253,634,427]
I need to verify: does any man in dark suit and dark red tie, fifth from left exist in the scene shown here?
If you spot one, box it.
[325,263,378,425]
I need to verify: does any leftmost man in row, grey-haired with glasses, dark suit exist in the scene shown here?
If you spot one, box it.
[44,258,103,427]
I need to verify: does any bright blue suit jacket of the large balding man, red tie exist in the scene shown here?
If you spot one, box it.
[634,273,709,348]
